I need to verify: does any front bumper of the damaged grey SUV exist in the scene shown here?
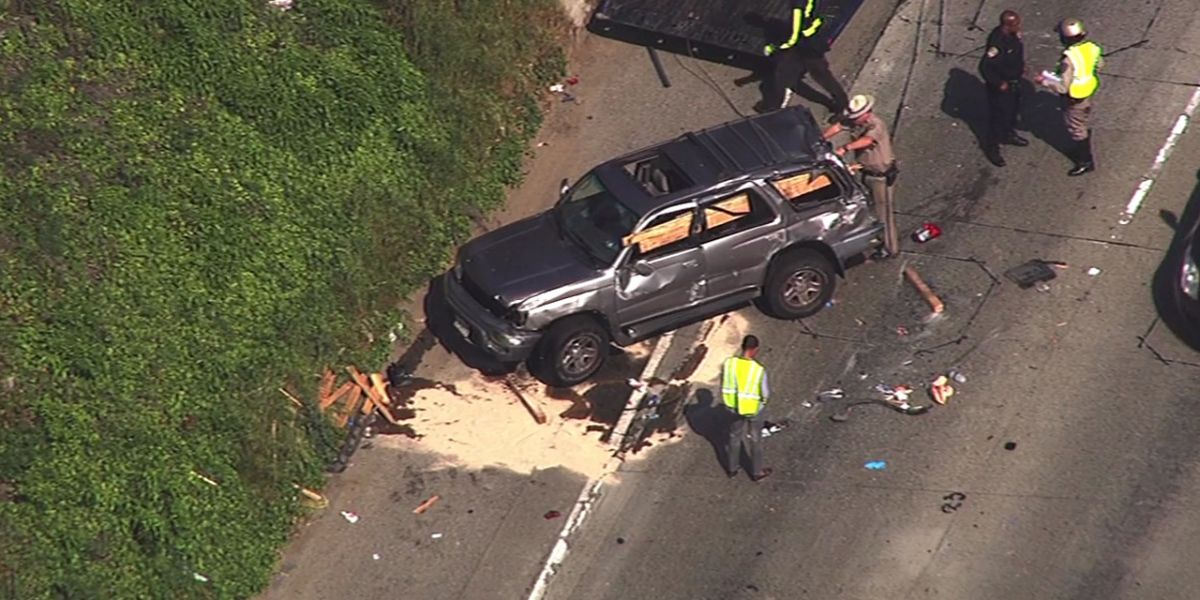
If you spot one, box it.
[444,272,541,362]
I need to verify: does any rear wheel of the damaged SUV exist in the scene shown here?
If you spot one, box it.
[758,250,838,319]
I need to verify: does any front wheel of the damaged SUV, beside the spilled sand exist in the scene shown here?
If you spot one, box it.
[529,316,608,388]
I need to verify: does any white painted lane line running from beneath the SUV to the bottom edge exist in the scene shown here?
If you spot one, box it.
[528,331,674,600]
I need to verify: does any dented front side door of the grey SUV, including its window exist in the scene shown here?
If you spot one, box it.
[616,202,707,326]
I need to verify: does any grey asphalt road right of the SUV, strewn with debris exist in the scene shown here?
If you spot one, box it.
[547,0,1200,600]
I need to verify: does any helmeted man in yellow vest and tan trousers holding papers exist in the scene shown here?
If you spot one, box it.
[1033,19,1104,176]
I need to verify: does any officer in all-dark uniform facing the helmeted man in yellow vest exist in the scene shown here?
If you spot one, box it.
[979,11,1030,167]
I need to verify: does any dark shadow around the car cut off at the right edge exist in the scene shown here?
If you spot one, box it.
[1151,172,1200,352]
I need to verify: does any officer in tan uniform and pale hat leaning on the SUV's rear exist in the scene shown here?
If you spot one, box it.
[824,94,900,258]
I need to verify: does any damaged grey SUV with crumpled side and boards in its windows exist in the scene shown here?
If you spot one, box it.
[445,107,882,385]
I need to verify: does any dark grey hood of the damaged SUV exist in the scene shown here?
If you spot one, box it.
[461,212,596,307]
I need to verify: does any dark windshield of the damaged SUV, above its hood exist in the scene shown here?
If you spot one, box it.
[554,173,637,265]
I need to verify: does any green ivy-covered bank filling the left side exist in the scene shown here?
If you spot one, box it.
[0,0,563,599]
